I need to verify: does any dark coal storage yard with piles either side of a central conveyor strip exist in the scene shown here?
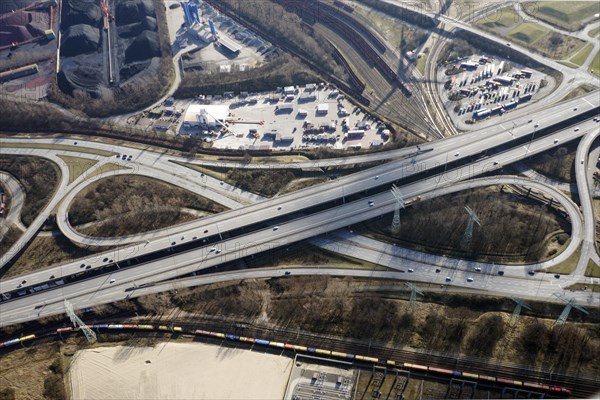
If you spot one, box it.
[57,0,161,103]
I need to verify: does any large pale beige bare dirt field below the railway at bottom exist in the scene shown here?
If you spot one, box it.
[68,343,292,400]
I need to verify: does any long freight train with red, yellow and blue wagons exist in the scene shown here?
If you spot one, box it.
[0,324,571,395]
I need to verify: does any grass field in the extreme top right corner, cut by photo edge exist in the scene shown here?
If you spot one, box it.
[523,1,600,31]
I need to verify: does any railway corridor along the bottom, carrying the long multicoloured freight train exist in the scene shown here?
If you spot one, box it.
[0,313,600,398]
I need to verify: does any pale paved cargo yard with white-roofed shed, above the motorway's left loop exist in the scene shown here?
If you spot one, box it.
[178,84,390,150]
